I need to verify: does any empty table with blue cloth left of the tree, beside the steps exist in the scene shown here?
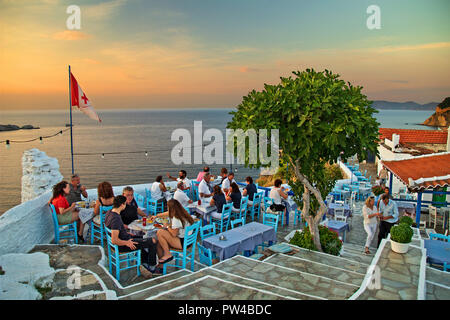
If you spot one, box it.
[202,222,277,260]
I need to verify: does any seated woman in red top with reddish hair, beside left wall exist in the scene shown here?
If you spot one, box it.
[50,181,84,242]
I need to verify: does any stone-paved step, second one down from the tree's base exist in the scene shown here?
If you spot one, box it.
[264,253,365,286]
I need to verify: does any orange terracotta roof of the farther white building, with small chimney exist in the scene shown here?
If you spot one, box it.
[379,128,447,144]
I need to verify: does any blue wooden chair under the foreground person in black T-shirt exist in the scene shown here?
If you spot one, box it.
[105,226,141,281]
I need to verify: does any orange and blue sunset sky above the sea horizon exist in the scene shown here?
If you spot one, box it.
[0,0,450,110]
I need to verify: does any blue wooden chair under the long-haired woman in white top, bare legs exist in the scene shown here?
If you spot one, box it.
[163,221,201,274]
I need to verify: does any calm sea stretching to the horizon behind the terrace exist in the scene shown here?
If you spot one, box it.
[0,109,435,215]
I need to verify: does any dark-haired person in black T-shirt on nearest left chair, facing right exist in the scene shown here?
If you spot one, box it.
[105,196,161,278]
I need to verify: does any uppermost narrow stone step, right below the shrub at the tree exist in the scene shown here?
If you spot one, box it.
[293,247,369,274]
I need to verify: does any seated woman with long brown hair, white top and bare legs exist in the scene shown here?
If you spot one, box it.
[150,199,194,264]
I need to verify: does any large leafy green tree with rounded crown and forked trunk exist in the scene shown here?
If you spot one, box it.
[227,69,378,251]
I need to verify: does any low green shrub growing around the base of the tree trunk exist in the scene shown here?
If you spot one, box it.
[289,226,342,256]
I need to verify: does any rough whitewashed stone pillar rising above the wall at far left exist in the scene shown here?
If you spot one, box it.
[22,148,63,202]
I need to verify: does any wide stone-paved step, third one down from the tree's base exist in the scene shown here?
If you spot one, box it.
[213,256,359,300]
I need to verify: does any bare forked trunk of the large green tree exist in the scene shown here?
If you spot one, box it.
[289,159,327,252]
